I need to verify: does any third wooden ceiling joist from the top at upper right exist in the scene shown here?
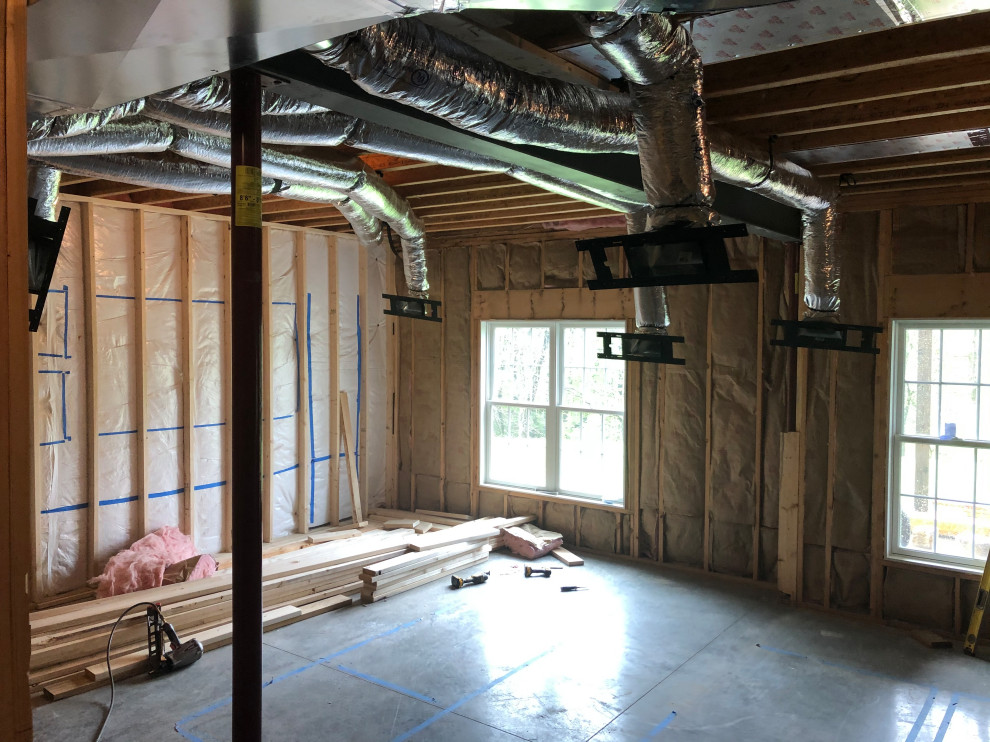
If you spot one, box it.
[732,85,990,137]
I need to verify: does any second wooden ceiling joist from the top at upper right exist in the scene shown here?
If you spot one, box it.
[706,54,990,124]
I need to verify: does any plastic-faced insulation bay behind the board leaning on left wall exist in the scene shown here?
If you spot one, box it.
[337,238,365,518]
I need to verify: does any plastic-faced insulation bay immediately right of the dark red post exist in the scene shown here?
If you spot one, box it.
[269,229,300,538]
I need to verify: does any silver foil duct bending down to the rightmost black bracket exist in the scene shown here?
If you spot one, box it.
[712,132,842,319]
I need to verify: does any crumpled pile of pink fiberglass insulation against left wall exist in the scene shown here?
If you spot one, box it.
[96,526,217,598]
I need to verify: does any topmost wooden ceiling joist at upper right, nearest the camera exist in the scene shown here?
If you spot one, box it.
[705,12,990,99]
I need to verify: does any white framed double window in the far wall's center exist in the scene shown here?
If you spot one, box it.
[481,321,625,505]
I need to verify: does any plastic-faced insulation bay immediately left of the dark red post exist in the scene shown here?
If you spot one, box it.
[191,219,230,551]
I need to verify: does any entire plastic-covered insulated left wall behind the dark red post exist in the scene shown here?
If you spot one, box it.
[34,201,372,596]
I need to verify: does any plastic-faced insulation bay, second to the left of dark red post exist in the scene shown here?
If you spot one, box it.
[138,212,186,531]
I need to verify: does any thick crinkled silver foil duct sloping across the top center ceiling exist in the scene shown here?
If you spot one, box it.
[309,19,636,152]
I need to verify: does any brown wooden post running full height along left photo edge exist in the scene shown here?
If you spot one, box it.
[0,0,33,742]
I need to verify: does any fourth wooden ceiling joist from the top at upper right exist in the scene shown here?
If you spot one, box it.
[776,108,990,152]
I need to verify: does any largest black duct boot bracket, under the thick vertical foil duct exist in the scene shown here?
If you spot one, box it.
[574,224,760,291]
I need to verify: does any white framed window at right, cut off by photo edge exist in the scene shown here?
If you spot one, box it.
[887,320,990,569]
